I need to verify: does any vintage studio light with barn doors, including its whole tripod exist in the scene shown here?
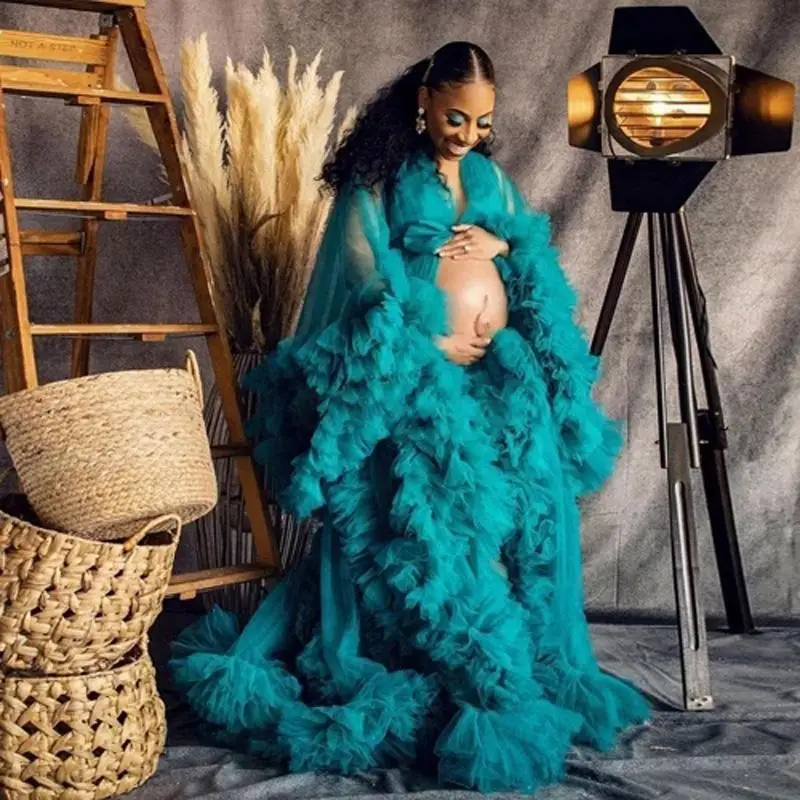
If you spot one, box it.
[567,6,795,711]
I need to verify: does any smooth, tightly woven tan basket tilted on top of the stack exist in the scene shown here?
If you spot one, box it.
[0,351,217,539]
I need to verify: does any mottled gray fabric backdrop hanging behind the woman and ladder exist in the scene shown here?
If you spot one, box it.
[0,0,800,620]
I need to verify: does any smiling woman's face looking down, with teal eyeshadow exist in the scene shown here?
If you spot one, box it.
[419,81,495,161]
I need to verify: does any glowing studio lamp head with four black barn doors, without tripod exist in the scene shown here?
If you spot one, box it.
[567,6,795,212]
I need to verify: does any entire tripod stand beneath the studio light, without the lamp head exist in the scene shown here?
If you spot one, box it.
[591,208,754,710]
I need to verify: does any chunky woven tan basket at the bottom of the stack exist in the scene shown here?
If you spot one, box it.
[0,643,166,800]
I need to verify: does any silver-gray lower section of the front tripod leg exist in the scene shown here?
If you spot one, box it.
[667,422,714,711]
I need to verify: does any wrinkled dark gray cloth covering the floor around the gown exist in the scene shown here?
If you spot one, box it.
[129,615,800,800]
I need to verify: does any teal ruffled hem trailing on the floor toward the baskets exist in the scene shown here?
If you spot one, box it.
[170,598,439,773]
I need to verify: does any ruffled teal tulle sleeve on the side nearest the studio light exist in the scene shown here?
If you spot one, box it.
[484,165,622,494]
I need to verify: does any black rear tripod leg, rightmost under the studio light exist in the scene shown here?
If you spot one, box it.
[676,210,755,633]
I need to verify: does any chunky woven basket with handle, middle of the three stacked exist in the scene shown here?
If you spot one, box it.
[0,511,181,675]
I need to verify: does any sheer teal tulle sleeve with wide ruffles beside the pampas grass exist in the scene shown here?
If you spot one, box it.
[246,182,445,516]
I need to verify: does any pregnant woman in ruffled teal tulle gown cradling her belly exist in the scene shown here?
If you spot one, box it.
[172,42,649,792]
